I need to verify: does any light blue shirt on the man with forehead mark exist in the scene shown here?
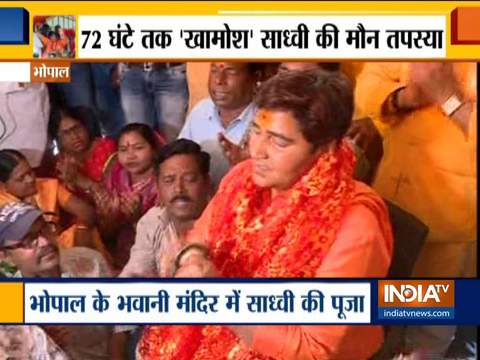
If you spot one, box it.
[178,98,257,187]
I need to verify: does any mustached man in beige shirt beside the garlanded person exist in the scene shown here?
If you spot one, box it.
[119,139,211,277]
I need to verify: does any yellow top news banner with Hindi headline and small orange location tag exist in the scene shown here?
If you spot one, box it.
[0,1,480,70]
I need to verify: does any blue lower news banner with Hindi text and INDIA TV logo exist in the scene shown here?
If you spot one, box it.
[0,278,480,325]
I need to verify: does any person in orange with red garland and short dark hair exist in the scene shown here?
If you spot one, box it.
[137,71,392,360]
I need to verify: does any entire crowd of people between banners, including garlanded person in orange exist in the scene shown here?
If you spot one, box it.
[0,62,477,360]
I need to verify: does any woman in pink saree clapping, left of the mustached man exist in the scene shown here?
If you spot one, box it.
[67,124,161,269]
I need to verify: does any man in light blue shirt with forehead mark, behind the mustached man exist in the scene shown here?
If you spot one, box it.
[179,62,260,187]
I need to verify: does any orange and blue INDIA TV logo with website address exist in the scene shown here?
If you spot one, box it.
[378,280,455,320]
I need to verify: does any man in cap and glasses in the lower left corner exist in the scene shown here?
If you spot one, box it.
[0,203,111,360]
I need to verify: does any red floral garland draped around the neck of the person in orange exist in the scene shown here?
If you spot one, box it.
[139,141,355,360]
